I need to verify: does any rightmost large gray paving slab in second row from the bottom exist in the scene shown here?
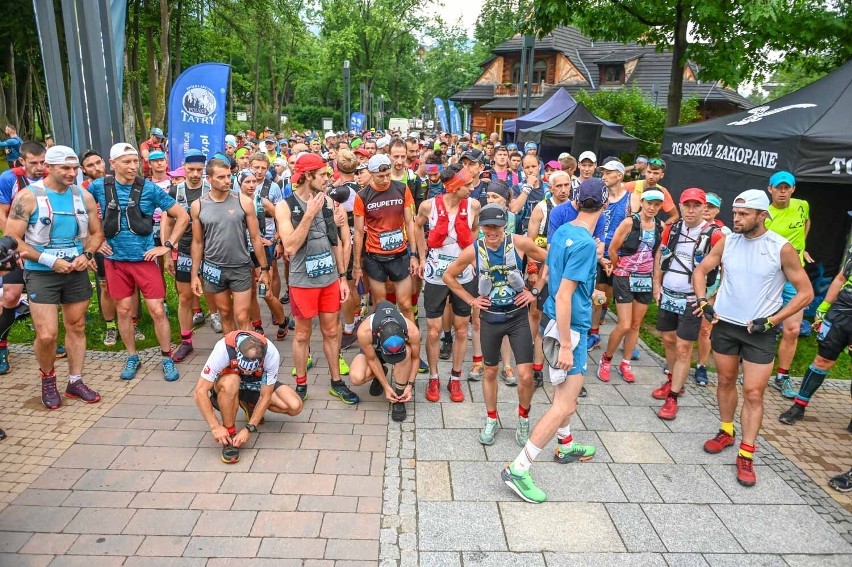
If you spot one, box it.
[713,504,852,554]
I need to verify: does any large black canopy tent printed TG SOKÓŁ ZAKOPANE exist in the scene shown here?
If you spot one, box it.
[662,61,852,272]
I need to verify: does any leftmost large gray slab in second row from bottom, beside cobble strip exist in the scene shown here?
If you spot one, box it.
[417,502,506,551]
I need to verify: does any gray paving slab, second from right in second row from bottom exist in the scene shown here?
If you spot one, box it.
[642,504,743,553]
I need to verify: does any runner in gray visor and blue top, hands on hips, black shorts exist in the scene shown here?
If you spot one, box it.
[444,204,547,446]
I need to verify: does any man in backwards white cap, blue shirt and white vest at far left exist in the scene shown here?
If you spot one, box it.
[5,146,104,410]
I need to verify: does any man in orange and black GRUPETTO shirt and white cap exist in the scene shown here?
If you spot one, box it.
[352,154,420,321]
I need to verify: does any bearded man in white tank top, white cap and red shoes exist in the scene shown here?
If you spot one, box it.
[692,189,814,486]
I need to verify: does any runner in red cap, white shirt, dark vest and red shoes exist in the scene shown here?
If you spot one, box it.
[645,188,724,420]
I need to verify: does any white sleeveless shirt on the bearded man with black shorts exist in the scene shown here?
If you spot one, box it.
[715,230,787,326]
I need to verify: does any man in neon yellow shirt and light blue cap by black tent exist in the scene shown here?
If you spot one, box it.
[766,171,813,399]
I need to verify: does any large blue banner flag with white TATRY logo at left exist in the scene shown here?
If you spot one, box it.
[169,63,231,169]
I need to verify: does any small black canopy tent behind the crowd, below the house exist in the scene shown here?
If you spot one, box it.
[518,102,639,156]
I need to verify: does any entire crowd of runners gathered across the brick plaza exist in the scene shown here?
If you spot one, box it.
[0,126,852,502]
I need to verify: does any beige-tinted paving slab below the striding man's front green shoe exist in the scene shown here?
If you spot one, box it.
[499,502,624,552]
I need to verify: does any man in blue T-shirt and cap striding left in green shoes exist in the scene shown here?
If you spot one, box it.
[502,179,608,502]
